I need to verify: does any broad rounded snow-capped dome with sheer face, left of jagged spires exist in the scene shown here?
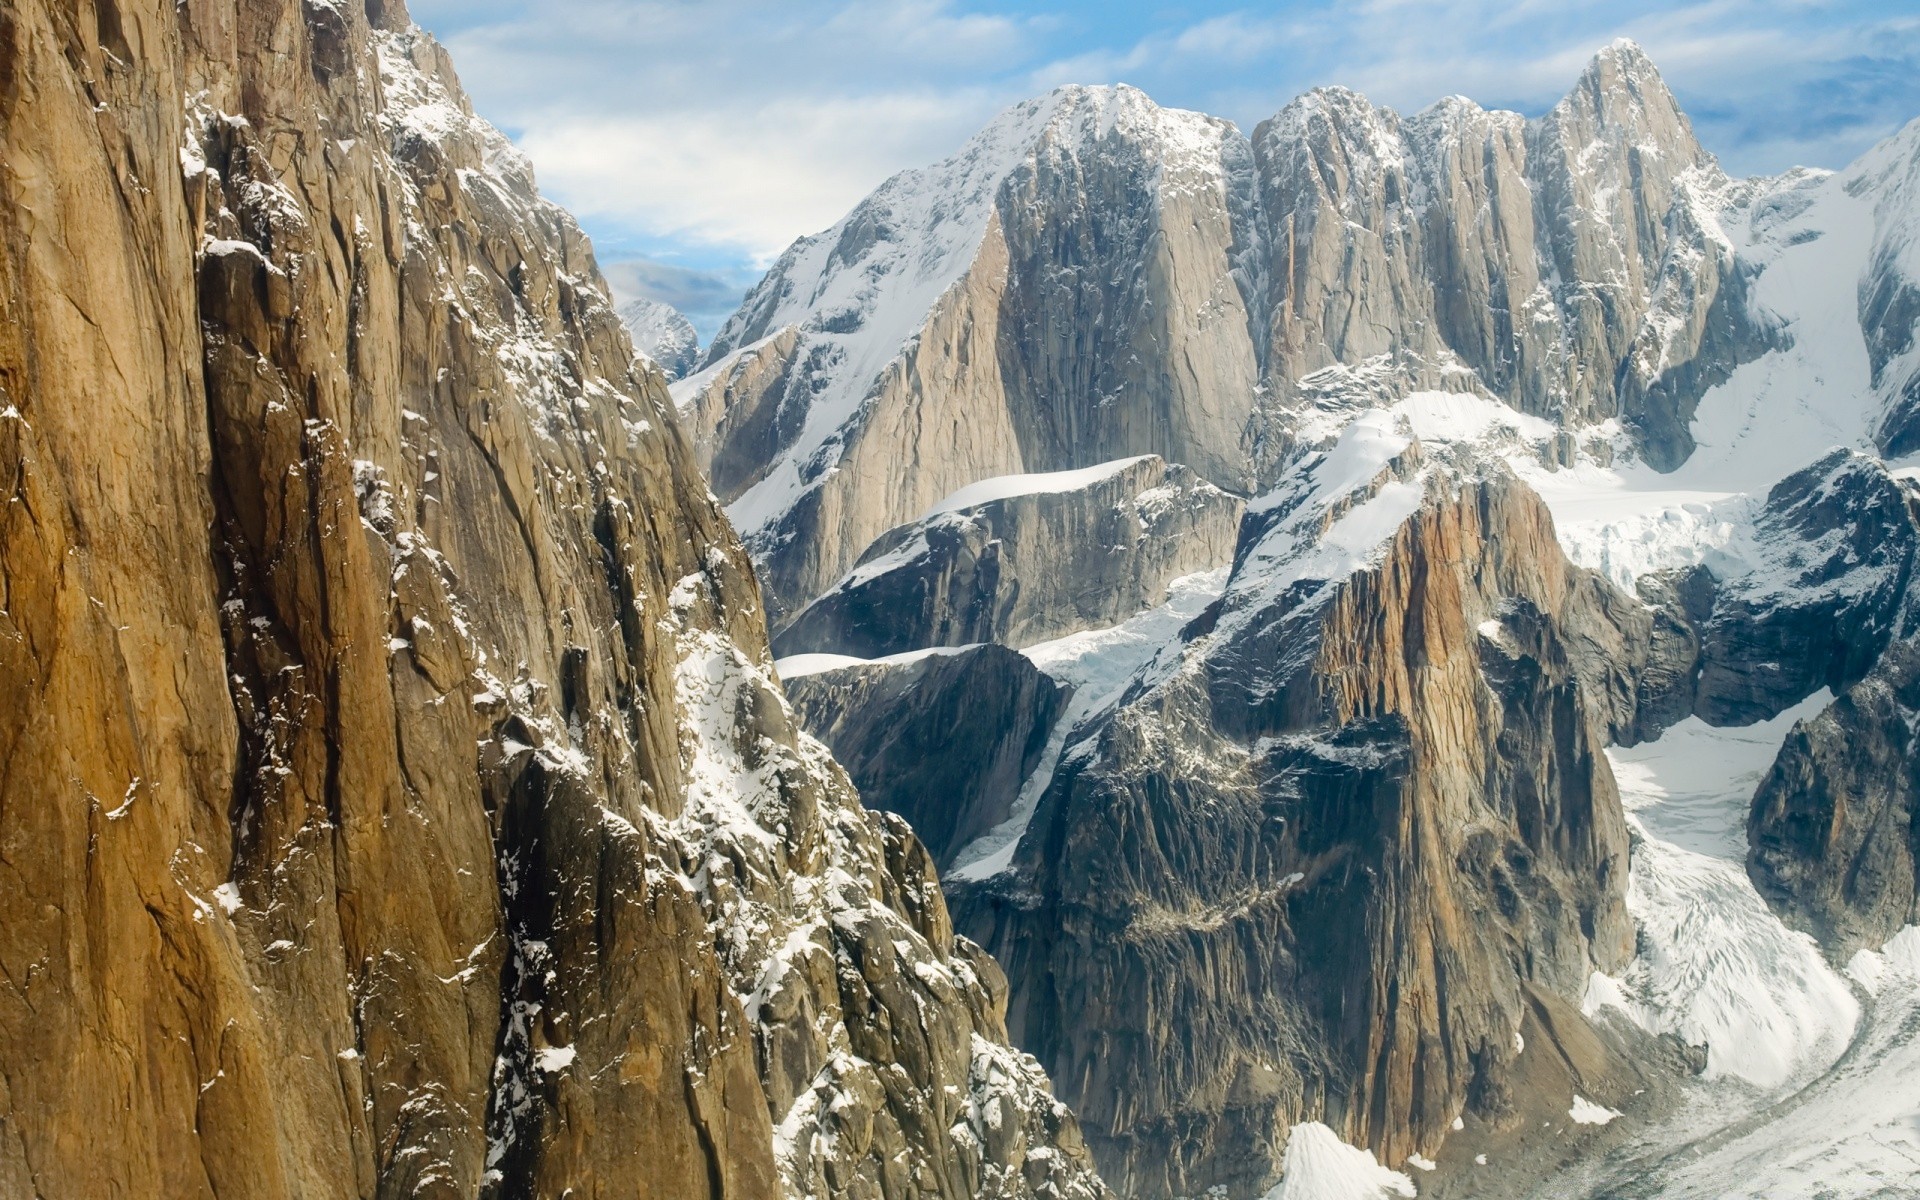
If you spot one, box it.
[676,86,1258,618]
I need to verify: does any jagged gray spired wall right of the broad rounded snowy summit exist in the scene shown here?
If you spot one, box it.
[1254,44,1770,468]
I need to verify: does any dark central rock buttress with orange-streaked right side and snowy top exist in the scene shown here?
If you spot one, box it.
[948,445,1632,1196]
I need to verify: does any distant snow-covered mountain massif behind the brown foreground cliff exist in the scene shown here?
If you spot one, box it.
[698,32,1920,1200]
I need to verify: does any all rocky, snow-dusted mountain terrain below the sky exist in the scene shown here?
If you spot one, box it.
[0,0,1920,1200]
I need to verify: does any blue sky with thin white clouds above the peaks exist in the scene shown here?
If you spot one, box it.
[411,0,1920,338]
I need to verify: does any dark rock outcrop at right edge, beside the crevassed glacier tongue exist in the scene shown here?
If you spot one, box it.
[1747,641,1920,962]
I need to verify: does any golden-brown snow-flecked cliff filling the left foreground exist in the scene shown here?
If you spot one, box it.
[0,0,1102,1196]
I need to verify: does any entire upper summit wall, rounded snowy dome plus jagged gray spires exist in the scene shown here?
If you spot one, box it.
[676,44,1782,618]
